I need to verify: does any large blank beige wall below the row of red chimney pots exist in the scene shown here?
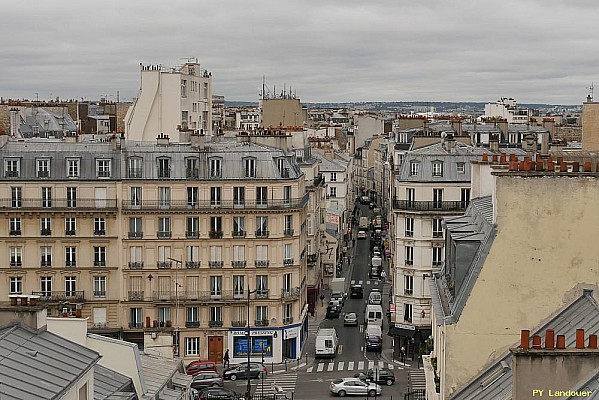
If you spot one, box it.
[442,175,599,395]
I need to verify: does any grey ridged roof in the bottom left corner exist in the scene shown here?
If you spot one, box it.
[0,325,100,400]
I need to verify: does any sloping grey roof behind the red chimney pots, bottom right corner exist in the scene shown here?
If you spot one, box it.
[451,293,599,400]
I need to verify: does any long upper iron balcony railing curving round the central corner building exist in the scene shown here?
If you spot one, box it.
[122,193,309,211]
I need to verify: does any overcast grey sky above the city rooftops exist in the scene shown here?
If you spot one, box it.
[0,0,599,104]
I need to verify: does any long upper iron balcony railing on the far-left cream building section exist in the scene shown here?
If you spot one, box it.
[0,198,117,211]
